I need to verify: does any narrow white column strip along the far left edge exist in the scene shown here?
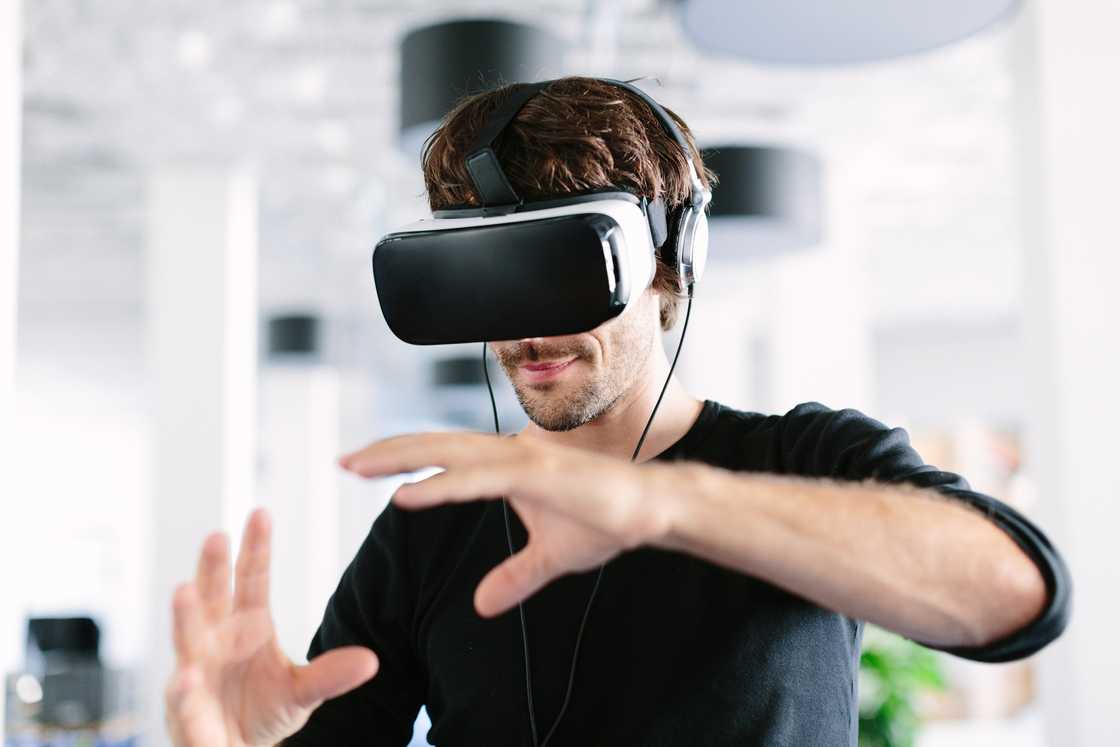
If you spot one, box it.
[0,0,22,735]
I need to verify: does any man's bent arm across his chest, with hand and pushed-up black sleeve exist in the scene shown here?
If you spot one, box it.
[340,403,1072,662]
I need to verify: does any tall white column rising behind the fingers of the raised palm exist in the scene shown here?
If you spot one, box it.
[144,166,258,745]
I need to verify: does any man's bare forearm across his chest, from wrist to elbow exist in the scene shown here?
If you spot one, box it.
[655,464,1046,646]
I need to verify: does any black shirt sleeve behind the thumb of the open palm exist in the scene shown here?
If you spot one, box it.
[283,503,426,747]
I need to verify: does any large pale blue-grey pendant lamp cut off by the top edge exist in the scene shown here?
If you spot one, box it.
[679,0,1021,65]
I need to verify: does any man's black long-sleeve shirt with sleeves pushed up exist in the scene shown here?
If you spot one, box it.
[284,400,1071,747]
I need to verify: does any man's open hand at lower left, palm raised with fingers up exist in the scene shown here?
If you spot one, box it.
[166,510,377,747]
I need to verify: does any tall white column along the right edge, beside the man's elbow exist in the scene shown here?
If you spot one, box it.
[1017,0,1120,746]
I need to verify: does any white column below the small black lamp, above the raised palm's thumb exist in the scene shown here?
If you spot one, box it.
[260,363,343,661]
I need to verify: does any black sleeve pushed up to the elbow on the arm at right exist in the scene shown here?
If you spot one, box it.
[778,402,1072,662]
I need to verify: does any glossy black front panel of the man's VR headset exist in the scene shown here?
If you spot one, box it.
[373,214,628,345]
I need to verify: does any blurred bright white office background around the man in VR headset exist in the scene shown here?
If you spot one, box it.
[0,0,1120,747]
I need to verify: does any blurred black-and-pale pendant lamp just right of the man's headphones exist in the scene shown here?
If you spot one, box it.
[702,146,823,262]
